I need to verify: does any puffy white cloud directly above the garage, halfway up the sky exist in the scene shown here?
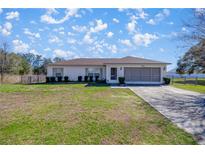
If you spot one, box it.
[133,33,158,47]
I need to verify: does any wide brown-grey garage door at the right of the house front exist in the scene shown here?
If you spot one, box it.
[124,67,160,82]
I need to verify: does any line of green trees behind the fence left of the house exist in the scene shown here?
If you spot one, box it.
[0,42,64,83]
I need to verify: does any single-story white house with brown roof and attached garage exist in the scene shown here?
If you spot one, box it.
[47,56,169,84]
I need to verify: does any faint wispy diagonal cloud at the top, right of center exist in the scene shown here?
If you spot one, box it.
[146,9,170,25]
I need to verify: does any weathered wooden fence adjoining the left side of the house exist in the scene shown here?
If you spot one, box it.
[21,75,46,84]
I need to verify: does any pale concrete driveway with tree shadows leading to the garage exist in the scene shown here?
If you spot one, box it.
[129,86,205,144]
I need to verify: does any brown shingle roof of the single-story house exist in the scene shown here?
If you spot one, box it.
[50,56,170,66]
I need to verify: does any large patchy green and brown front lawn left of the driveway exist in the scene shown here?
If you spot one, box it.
[0,84,196,144]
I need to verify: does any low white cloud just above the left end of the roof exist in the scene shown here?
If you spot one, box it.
[53,49,78,59]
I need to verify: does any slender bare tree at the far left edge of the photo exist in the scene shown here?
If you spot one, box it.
[0,42,9,83]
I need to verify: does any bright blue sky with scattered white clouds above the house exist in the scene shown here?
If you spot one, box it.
[0,9,193,69]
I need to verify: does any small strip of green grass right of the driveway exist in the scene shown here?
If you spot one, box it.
[173,79,205,93]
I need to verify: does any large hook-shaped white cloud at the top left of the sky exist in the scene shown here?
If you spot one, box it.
[41,8,79,24]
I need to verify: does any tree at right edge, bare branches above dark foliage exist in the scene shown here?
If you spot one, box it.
[177,9,205,74]
